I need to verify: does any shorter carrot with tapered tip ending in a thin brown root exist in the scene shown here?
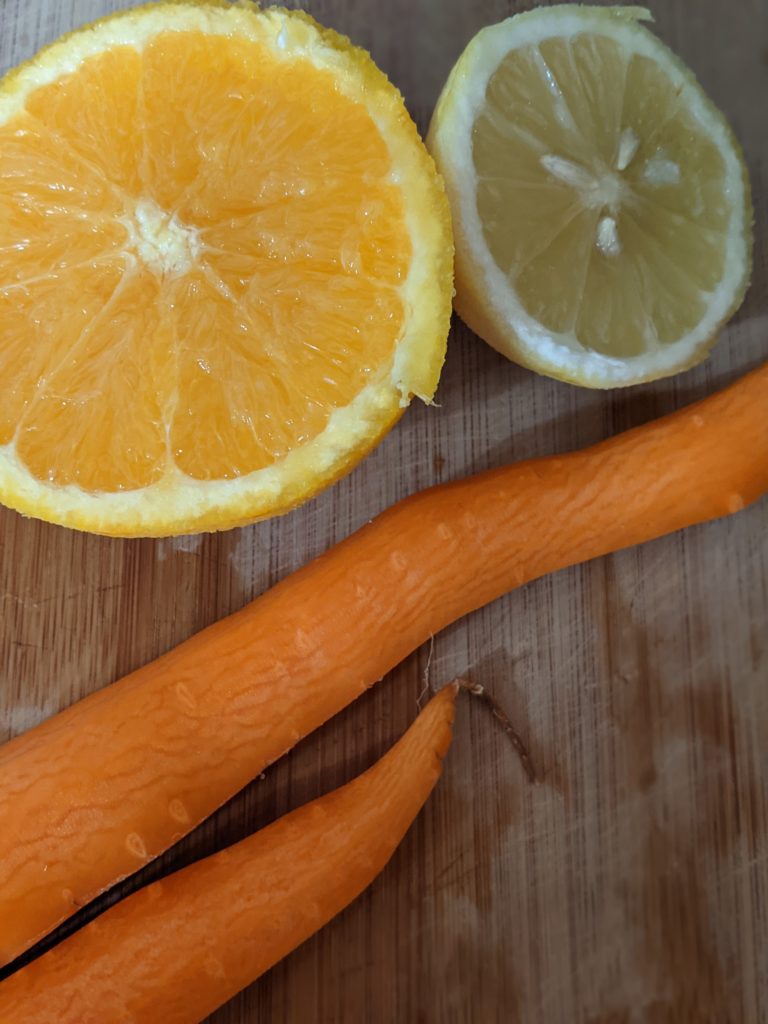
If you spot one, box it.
[0,684,458,1024]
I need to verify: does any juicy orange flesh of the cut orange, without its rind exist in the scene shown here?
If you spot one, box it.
[0,32,411,492]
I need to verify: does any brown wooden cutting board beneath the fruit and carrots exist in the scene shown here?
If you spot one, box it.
[0,0,768,1024]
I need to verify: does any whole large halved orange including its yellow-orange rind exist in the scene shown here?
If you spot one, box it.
[0,2,453,536]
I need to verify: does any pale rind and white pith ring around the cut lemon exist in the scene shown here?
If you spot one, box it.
[427,4,752,388]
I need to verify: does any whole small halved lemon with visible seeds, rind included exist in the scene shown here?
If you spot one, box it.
[428,5,752,387]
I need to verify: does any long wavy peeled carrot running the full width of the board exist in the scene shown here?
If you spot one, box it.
[0,365,768,961]
